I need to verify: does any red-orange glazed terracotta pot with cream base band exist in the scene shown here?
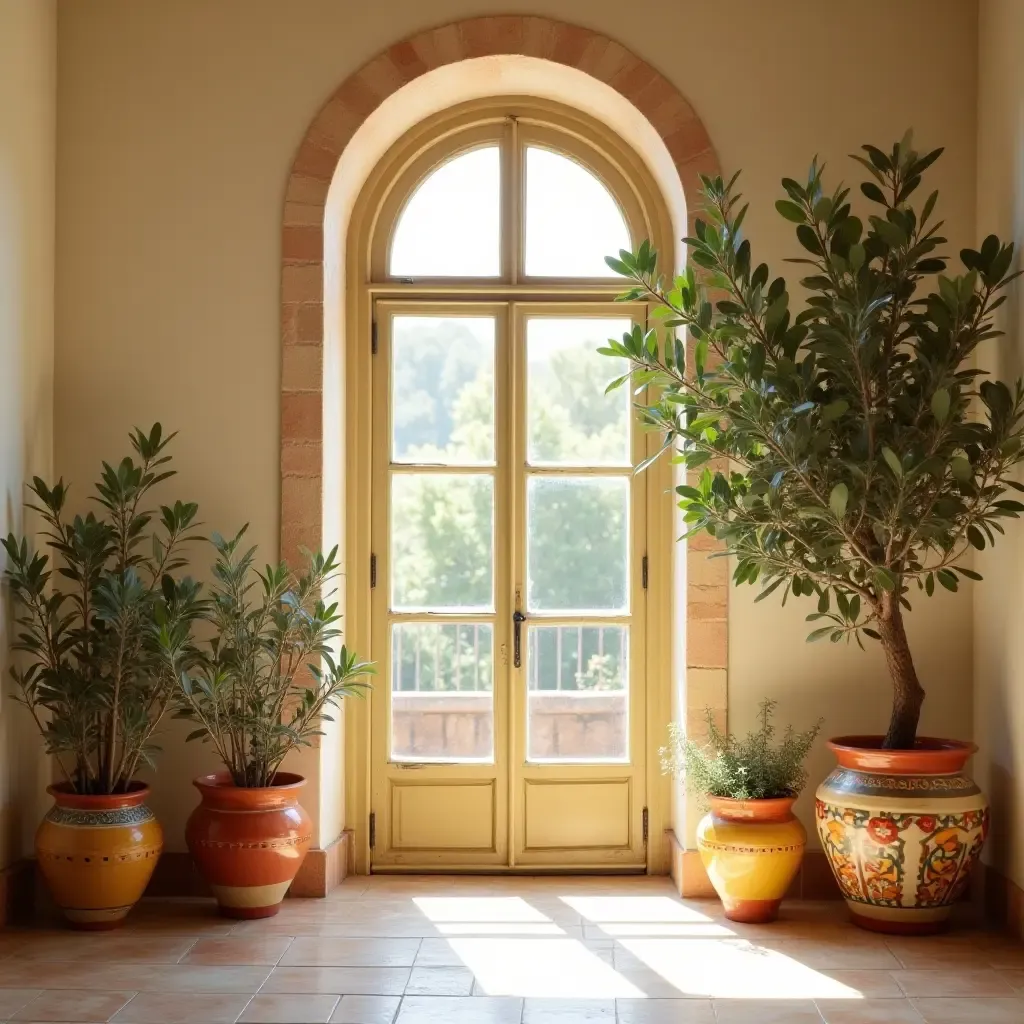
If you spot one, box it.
[185,772,312,918]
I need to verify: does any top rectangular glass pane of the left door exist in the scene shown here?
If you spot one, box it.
[391,316,495,466]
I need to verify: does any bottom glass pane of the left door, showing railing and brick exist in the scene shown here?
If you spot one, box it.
[391,623,495,761]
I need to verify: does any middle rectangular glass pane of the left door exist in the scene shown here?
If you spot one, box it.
[391,473,495,611]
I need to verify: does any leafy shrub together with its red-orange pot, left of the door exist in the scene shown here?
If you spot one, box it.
[174,527,372,918]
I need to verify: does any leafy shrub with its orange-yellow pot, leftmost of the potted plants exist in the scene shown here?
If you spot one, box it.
[3,423,202,929]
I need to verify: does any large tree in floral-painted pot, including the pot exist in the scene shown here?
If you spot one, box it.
[603,133,1024,931]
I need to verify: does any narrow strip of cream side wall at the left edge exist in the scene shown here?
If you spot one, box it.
[0,0,56,867]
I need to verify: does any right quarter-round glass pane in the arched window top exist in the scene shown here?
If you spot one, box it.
[524,146,632,278]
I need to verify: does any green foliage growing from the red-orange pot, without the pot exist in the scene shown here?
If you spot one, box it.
[167,526,373,787]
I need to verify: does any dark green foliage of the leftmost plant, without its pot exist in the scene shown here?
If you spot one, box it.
[2,423,205,795]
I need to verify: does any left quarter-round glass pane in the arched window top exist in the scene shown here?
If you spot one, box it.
[389,145,501,278]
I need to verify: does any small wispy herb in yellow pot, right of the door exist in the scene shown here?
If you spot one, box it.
[662,700,821,925]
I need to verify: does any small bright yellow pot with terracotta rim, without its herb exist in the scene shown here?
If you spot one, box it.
[697,797,807,924]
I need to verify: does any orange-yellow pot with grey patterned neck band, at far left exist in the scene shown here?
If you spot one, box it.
[36,782,164,929]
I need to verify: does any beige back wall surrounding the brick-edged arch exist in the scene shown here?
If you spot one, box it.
[55,0,977,849]
